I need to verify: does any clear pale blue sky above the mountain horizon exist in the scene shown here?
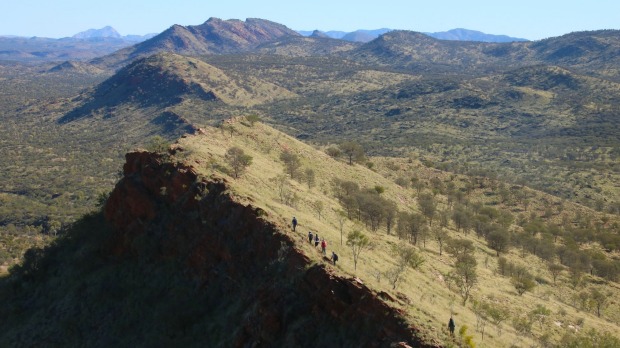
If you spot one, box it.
[0,0,620,40]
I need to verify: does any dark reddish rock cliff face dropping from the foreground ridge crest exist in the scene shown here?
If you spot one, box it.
[105,152,438,347]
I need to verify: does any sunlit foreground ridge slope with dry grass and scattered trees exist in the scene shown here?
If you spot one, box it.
[170,119,620,347]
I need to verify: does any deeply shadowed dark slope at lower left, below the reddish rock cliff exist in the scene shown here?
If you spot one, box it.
[0,213,234,347]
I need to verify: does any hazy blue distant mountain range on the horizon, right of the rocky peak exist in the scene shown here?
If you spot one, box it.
[298,28,529,42]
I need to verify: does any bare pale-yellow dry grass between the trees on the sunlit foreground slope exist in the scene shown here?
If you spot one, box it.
[173,121,620,347]
